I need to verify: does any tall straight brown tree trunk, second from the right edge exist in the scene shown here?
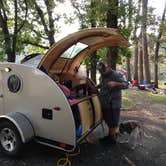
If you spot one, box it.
[142,0,151,83]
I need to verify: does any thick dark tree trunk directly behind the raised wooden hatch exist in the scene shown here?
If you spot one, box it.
[107,0,119,70]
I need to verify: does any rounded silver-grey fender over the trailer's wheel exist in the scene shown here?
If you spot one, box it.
[0,112,35,143]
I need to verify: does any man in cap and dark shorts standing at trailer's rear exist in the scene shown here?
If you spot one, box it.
[98,61,128,143]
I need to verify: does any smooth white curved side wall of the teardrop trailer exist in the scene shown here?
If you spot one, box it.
[0,63,76,146]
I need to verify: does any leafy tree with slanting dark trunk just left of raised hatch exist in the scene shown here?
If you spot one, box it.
[23,0,61,49]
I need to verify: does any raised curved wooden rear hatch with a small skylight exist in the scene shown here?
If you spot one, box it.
[38,28,130,74]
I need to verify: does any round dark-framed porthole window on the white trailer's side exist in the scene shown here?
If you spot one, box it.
[7,75,21,93]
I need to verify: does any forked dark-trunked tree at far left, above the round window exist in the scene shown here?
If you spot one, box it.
[0,0,28,62]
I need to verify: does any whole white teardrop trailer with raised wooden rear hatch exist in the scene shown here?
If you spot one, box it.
[0,28,129,156]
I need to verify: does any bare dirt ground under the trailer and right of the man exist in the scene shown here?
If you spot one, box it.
[0,92,166,166]
